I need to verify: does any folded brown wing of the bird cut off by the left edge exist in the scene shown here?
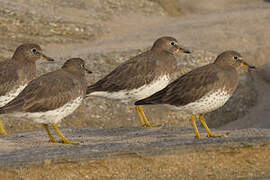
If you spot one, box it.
[0,60,19,96]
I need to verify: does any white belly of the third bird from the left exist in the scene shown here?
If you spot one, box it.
[89,75,170,102]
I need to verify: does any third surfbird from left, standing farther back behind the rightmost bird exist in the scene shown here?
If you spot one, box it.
[86,37,190,127]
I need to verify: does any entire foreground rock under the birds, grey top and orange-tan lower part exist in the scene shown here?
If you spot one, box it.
[0,127,270,179]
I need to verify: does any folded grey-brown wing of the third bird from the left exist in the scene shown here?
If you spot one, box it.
[86,52,166,94]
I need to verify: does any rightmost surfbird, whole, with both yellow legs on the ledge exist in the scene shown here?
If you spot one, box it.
[135,51,255,139]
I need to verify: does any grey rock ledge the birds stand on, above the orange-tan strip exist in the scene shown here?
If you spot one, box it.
[0,127,270,169]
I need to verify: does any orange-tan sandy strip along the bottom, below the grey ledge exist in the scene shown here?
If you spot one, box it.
[0,146,270,180]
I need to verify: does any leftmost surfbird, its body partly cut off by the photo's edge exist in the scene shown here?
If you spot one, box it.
[0,44,53,135]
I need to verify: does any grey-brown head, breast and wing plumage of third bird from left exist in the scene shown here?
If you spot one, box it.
[87,37,190,94]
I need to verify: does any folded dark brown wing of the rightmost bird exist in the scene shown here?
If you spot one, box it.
[135,64,222,106]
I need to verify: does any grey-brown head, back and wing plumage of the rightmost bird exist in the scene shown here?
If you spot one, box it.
[135,51,254,113]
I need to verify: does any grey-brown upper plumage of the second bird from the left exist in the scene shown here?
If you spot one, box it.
[0,58,90,114]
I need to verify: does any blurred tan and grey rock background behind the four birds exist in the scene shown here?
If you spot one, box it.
[0,0,270,133]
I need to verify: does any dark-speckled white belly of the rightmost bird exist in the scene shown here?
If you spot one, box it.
[167,89,231,114]
